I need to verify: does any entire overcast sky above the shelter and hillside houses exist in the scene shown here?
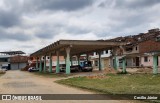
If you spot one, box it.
[0,0,160,53]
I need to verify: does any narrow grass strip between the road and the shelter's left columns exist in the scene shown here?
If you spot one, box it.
[32,72,71,78]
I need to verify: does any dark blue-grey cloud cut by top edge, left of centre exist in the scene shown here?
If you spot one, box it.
[26,0,94,11]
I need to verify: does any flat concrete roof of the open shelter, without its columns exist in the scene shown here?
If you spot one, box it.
[31,40,126,56]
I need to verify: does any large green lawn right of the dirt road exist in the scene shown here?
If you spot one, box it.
[56,74,160,94]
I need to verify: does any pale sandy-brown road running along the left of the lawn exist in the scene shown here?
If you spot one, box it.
[0,70,141,103]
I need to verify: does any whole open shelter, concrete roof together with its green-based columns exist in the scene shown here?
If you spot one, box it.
[31,40,126,74]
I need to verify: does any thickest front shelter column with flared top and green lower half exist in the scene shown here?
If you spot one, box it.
[66,47,71,74]
